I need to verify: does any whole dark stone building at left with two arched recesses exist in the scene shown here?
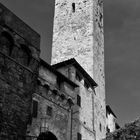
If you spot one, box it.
[0,1,40,140]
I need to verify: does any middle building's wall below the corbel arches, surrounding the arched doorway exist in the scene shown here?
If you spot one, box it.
[27,94,70,140]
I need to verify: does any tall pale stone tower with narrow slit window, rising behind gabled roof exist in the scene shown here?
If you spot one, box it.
[51,0,106,140]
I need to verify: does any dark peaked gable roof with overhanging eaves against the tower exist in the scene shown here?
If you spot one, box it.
[52,58,97,87]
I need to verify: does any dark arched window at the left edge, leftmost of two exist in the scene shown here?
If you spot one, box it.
[0,31,14,55]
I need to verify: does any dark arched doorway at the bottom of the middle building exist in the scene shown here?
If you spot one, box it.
[37,131,58,140]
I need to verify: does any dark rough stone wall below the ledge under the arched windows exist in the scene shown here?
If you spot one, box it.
[0,53,36,136]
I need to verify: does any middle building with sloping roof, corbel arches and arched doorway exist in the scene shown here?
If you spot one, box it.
[27,60,78,140]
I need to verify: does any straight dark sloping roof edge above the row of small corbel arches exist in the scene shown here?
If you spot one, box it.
[40,59,78,87]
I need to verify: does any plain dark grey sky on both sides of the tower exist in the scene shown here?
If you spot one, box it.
[0,0,140,126]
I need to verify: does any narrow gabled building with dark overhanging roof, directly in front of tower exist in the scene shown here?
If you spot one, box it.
[53,59,97,140]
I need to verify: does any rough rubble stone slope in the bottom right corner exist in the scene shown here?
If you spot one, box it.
[105,118,140,140]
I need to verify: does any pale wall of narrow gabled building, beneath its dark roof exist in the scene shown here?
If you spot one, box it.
[52,62,96,140]
